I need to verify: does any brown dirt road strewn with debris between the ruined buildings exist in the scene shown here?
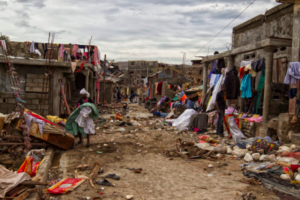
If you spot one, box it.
[49,105,279,200]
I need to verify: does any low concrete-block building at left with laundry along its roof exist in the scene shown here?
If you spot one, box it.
[0,41,95,116]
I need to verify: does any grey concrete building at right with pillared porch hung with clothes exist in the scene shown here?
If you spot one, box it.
[202,0,300,139]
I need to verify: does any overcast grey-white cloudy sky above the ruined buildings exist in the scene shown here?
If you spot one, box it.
[0,0,278,64]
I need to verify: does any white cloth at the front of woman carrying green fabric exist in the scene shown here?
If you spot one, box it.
[75,106,95,134]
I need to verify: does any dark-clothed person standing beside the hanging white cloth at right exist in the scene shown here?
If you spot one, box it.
[216,84,227,137]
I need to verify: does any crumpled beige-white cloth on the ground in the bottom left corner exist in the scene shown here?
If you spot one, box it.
[0,165,31,198]
